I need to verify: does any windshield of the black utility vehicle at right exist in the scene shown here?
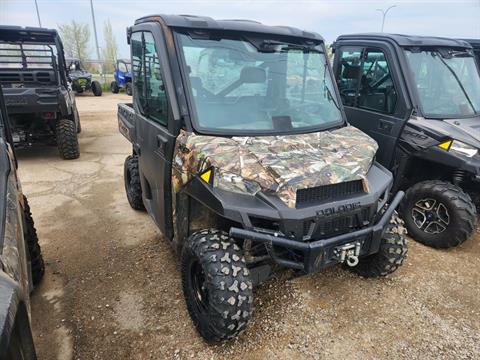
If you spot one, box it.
[405,49,480,118]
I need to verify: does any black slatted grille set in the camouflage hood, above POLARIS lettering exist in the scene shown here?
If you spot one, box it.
[296,180,364,208]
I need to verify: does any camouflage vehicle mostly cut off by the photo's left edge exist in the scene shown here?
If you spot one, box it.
[0,87,45,360]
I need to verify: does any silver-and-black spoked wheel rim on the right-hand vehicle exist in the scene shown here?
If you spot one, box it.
[411,198,450,235]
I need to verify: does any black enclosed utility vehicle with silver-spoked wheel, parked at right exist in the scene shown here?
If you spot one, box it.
[333,34,480,248]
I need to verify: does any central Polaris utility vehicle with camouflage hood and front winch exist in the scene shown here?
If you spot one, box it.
[118,15,407,341]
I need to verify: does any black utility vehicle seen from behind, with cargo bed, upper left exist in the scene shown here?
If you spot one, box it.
[0,26,81,159]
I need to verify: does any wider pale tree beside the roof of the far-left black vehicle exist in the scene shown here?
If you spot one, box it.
[58,20,90,61]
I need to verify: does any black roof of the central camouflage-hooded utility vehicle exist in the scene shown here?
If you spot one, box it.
[135,15,323,41]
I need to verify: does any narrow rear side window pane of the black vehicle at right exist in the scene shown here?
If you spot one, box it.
[337,48,362,106]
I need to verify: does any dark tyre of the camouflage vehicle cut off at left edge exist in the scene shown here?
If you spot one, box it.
[23,195,45,286]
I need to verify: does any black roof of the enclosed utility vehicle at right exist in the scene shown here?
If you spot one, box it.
[337,33,471,48]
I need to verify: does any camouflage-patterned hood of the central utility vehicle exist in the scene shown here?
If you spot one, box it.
[173,126,377,207]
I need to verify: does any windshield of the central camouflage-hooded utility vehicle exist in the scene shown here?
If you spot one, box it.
[178,34,343,135]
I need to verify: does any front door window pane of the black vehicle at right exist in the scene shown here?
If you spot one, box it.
[358,49,397,114]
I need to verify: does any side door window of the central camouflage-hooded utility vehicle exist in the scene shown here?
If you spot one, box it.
[130,32,168,126]
